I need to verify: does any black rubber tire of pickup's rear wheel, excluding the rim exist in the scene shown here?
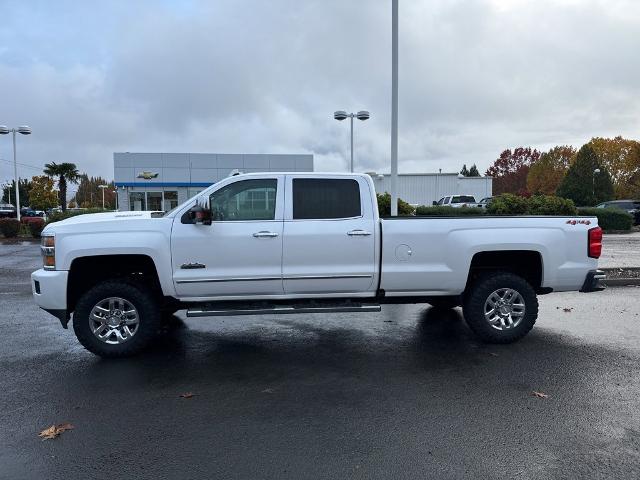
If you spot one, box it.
[463,272,538,343]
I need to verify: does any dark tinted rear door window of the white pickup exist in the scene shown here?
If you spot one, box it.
[293,178,362,220]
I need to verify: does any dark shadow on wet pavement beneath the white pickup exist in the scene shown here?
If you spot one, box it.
[91,308,616,380]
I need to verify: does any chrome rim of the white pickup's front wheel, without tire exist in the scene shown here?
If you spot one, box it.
[89,297,140,345]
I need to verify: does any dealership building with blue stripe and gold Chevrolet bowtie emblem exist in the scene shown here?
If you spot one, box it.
[113,152,313,211]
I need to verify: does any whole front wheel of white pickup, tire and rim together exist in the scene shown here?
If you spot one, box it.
[73,280,161,358]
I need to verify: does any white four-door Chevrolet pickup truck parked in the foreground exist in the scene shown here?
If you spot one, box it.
[32,173,604,357]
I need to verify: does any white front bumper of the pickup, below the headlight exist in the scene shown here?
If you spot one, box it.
[31,268,69,328]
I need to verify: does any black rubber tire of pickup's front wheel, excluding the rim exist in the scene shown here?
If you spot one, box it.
[73,280,162,358]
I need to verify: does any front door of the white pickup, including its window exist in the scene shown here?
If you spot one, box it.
[171,175,284,297]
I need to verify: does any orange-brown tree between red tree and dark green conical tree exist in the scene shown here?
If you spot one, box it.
[527,145,576,195]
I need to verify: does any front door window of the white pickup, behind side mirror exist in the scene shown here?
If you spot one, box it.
[209,178,278,222]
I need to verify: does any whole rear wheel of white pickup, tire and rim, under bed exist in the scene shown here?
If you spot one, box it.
[463,272,538,343]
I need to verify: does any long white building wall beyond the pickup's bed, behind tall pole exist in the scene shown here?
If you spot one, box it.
[370,173,493,205]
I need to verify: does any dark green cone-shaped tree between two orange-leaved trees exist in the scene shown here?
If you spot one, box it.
[556,144,613,206]
